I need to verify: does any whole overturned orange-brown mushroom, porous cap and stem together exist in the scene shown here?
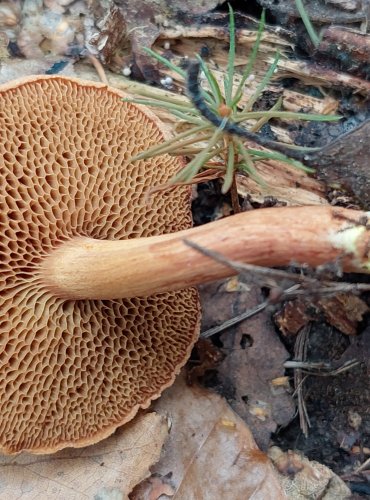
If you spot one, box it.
[0,76,370,454]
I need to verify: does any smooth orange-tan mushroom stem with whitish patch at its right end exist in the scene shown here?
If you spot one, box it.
[41,207,370,299]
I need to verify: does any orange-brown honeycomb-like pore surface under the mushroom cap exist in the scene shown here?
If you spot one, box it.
[0,77,199,453]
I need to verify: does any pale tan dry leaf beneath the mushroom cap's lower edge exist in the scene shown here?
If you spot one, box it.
[0,413,168,500]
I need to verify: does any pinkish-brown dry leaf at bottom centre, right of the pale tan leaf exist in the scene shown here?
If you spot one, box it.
[144,376,285,500]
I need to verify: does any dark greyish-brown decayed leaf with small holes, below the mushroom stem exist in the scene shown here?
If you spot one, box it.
[200,279,295,449]
